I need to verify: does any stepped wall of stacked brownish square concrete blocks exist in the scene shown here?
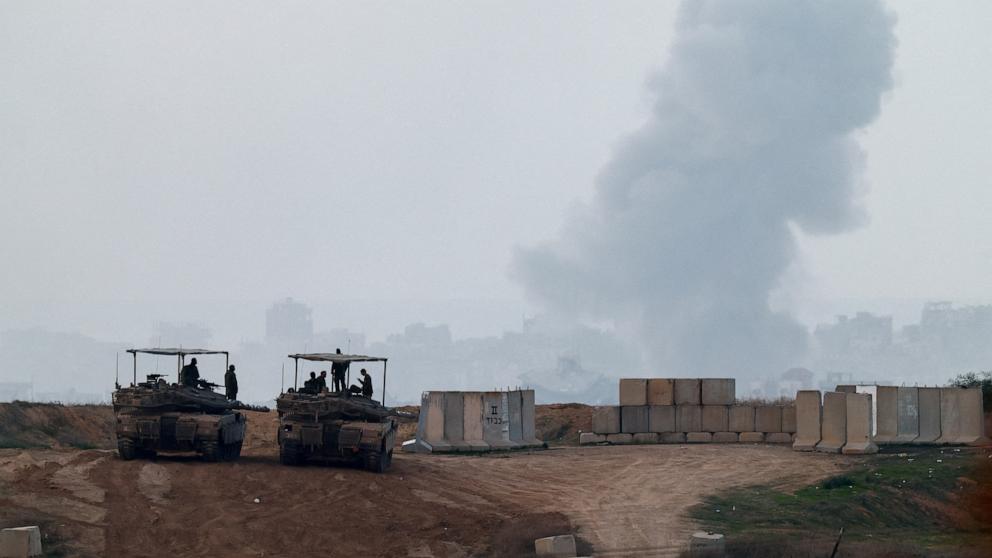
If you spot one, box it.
[579,378,797,444]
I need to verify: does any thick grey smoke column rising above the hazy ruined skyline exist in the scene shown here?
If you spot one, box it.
[512,0,895,378]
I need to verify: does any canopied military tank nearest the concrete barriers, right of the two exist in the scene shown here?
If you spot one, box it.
[276,353,399,473]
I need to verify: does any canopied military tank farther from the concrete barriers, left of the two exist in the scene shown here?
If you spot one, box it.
[113,349,268,461]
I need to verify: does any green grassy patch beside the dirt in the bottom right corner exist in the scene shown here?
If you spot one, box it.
[690,448,988,547]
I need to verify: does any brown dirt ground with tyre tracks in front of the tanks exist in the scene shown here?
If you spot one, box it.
[0,438,849,557]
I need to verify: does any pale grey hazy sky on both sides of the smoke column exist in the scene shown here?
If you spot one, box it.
[0,0,992,341]
